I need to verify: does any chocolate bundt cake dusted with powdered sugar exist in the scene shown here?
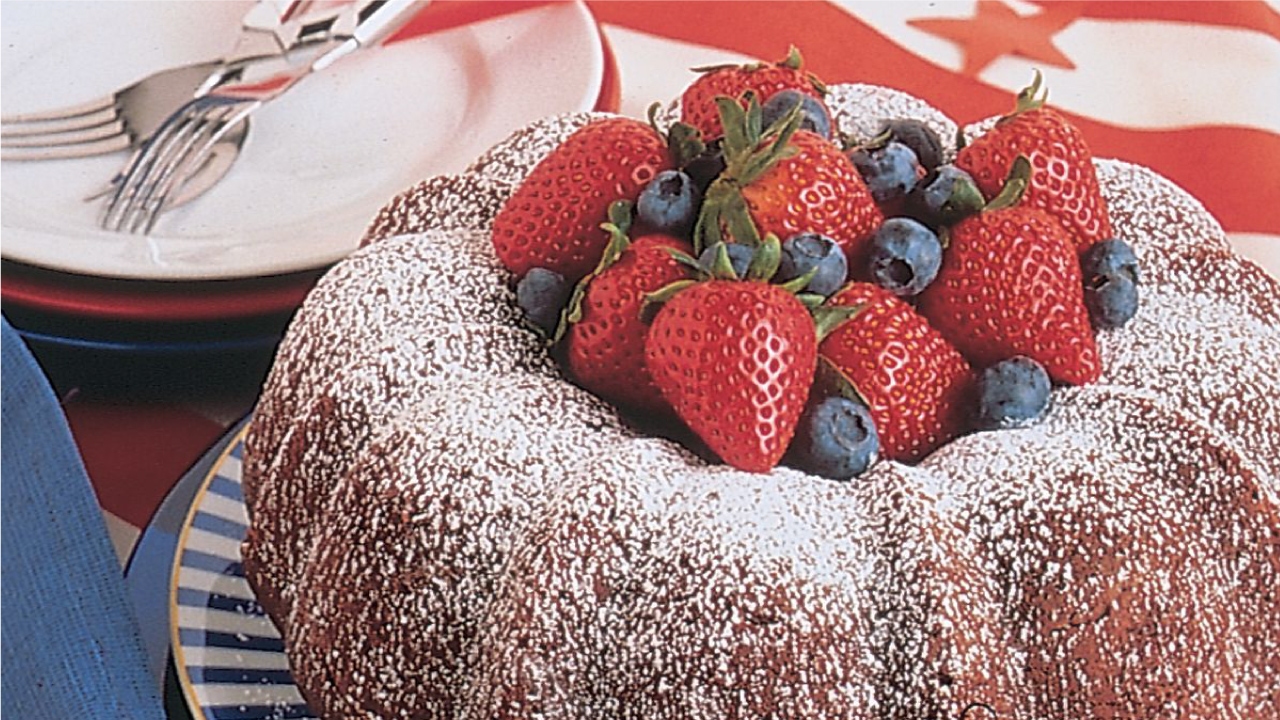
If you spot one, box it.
[243,85,1280,720]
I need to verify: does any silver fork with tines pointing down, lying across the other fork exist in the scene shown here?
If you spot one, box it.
[99,0,425,234]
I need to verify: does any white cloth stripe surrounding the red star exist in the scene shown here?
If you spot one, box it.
[840,0,1280,133]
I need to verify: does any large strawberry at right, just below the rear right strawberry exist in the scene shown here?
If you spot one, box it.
[919,159,1102,384]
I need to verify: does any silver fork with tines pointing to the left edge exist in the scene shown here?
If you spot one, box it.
[0,0,311,160]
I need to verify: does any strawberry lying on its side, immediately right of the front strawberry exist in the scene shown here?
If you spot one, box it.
[818,282,974,462]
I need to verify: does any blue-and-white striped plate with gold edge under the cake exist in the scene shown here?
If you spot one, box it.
[169,429,315,720]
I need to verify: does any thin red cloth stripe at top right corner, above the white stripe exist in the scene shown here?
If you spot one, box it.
[1036,0,1280,40]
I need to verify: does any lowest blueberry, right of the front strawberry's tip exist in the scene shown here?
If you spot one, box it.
[791,396,879,480]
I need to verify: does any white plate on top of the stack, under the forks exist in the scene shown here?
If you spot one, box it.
[0,1,604,279]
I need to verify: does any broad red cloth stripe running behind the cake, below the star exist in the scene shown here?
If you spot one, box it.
[589,0,1280,234]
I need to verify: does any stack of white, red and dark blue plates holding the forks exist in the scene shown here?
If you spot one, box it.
[0,1,616,392]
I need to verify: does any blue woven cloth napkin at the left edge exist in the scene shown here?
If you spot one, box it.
[0,320,164,720]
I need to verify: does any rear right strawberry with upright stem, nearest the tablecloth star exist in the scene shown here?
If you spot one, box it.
[955,72,1112,252]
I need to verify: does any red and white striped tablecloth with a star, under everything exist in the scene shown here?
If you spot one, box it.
[90,0,1280,552]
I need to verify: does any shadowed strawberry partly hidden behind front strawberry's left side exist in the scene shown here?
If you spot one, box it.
[564,202,691,413]
